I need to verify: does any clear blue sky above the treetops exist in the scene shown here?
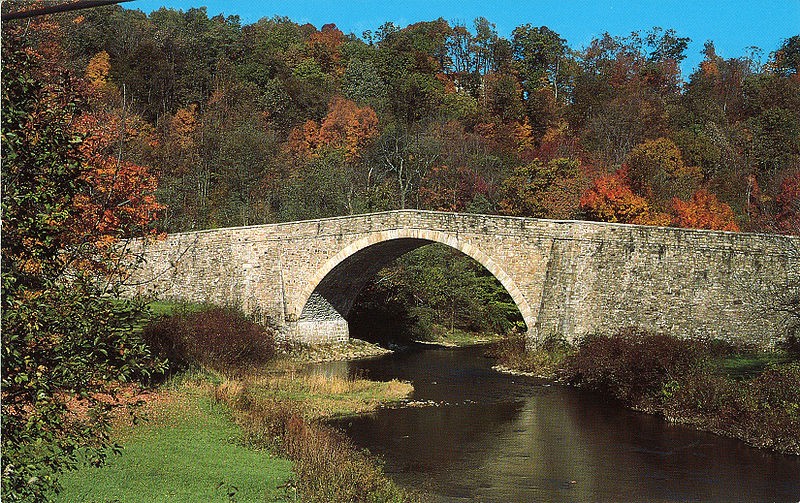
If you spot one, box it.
[128,0,800,75]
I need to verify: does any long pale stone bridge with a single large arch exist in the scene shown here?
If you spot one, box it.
[127,210,800,344]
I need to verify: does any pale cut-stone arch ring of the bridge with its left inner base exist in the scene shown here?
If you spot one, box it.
[290,229,536,342]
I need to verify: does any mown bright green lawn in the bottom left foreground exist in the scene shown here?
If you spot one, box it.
[56,392,292,503]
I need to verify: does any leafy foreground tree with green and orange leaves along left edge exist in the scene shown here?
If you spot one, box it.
[2,22,160,501]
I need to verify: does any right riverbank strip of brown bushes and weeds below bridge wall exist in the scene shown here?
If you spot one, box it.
[494,329,800,454]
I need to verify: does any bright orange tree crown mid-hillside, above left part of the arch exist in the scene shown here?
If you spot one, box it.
[287,96,378,162]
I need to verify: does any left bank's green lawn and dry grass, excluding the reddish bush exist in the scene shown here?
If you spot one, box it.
[57,359,415,502]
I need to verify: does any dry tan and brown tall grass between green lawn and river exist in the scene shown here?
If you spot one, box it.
[217,376,419,503]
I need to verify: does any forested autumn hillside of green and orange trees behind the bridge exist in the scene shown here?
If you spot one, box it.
[48,7,800,233]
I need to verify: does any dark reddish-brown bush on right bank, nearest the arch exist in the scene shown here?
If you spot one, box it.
[565,328,707,410]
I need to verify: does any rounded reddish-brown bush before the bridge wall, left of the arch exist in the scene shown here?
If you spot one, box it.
[144,307,275,374]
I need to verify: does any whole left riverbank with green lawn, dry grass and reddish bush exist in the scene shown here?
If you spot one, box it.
[58,306,418,502]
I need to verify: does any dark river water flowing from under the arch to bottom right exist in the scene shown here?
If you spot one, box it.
[312,347,800,502]
